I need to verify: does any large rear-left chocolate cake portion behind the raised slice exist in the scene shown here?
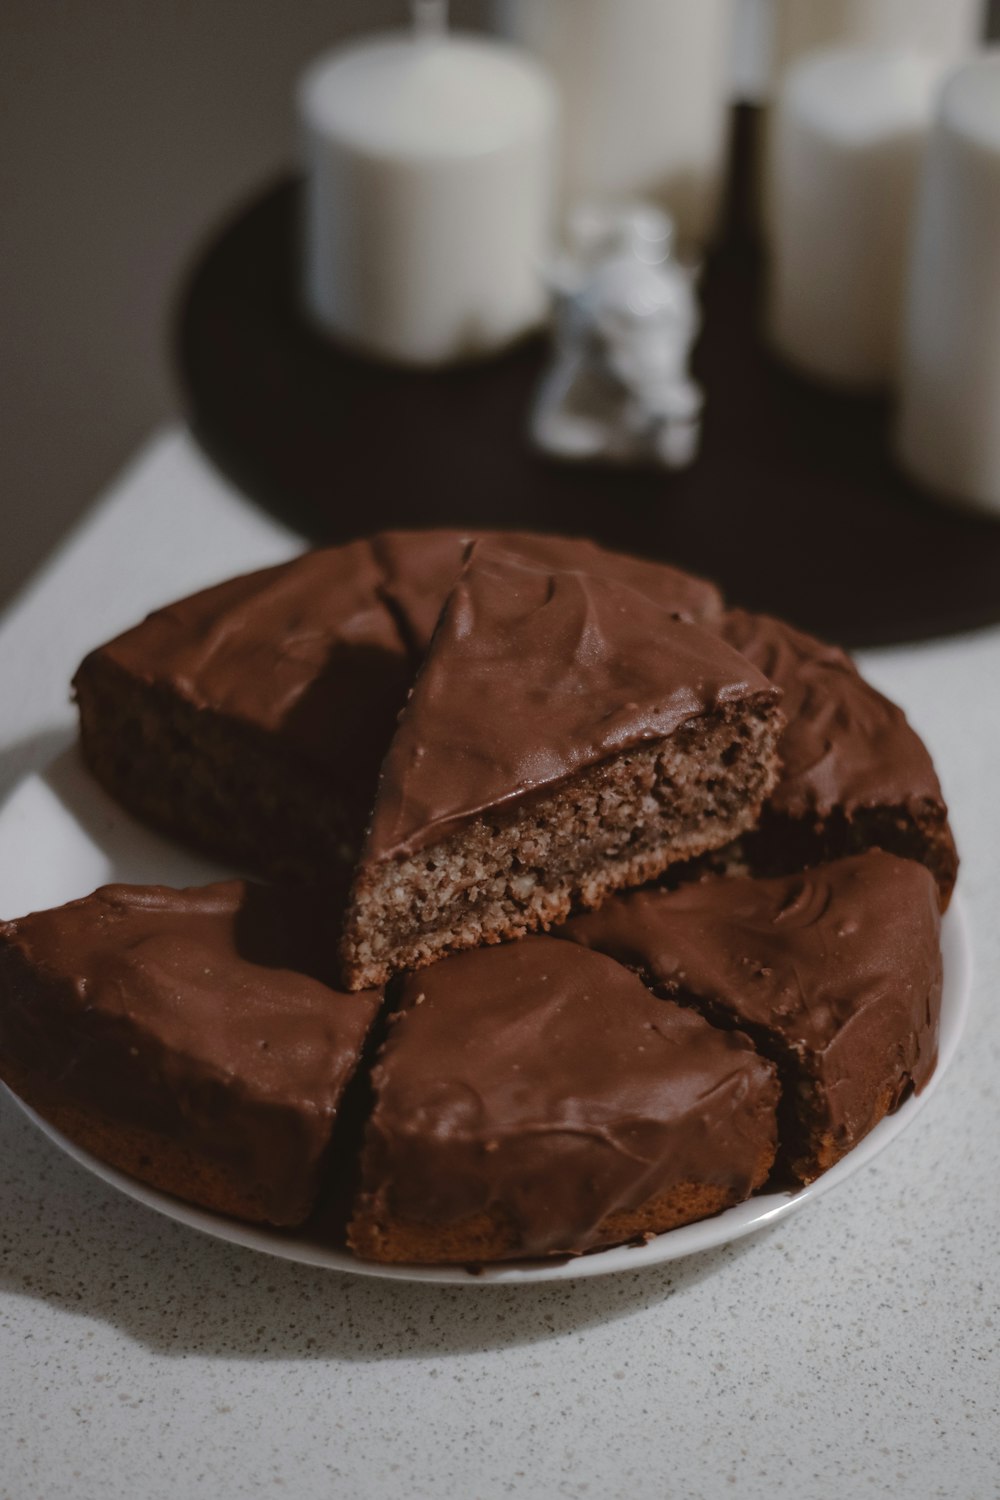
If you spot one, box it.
[73,531,721,881]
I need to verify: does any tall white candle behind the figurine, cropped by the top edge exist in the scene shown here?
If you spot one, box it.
[495,0,733,243]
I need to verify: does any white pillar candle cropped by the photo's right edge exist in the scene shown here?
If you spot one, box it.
[897,51,1000,515]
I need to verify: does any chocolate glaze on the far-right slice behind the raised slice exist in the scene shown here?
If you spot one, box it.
[723,609,942,818]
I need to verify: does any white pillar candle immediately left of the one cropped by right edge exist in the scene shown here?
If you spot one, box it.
[766,50,943,389]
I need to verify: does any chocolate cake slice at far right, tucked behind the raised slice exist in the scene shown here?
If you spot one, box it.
[723,609,958,909]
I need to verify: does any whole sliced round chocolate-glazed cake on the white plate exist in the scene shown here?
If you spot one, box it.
[0,531,958,1263]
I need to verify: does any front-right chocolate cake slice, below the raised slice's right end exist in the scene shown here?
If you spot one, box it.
[562,851,942,1182]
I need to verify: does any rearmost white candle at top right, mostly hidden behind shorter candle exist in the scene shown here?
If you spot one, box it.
[774,0,985,80]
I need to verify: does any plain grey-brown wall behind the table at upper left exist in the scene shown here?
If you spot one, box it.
[0,0,1000,602]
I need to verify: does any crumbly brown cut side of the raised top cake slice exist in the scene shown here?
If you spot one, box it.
[340,696,780,990]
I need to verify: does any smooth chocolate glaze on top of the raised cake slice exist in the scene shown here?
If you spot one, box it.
[364,542,778,860]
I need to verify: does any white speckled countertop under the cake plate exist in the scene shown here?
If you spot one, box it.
[0,429,1000,1500]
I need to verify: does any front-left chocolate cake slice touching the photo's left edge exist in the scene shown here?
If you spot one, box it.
[0,882,381,1226]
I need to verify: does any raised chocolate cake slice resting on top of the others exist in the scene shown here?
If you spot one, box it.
[342,543,781,989]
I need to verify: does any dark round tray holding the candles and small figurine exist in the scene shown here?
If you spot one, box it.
[177,105,1000,647]
